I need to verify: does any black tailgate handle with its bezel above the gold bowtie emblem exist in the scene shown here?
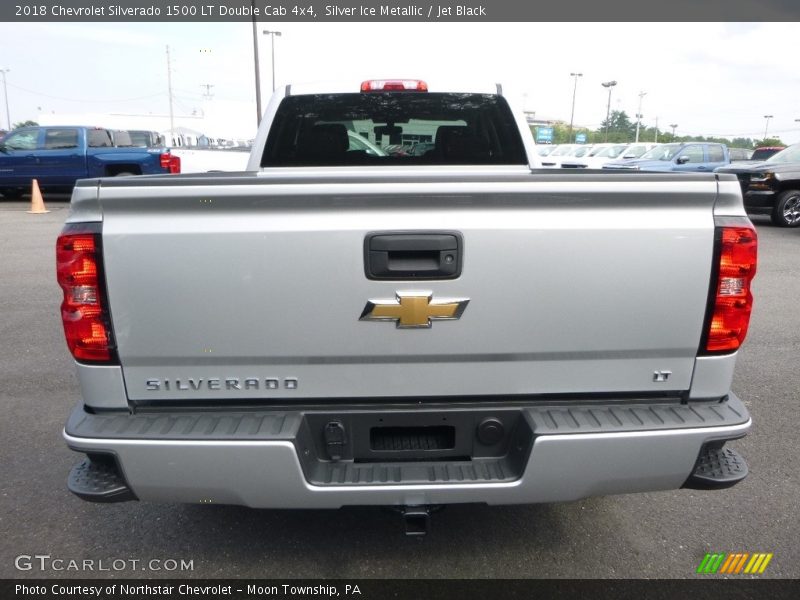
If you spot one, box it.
[364,232,463,279]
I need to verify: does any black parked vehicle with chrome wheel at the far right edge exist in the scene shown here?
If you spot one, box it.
[716,144,800,227]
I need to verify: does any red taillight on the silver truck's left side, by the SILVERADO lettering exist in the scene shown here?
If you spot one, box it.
[56,232,112,362]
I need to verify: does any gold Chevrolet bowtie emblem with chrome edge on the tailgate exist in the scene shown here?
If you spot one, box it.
[360,292,469,328]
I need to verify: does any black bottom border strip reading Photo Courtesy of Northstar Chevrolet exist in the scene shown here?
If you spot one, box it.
[0,576,800,600]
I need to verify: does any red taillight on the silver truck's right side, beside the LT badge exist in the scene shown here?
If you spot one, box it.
[705,224,758,353]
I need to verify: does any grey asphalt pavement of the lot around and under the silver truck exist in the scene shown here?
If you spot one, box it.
[0,199,800,578]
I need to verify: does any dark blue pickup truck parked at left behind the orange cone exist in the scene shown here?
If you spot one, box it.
[0,127,180,198]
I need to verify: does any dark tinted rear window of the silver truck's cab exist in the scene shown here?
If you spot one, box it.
[261,92,528,167]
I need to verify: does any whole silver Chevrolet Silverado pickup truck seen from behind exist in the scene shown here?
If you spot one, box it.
[57,81,756,531]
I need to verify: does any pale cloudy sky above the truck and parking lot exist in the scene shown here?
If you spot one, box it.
[0,23,800,143]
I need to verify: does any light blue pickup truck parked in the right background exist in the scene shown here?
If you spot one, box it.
[603,142,731,173]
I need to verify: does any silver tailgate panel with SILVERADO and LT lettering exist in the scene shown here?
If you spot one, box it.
[99,169,717,404]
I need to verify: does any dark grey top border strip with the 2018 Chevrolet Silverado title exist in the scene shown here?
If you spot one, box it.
[0,0,800,23]
